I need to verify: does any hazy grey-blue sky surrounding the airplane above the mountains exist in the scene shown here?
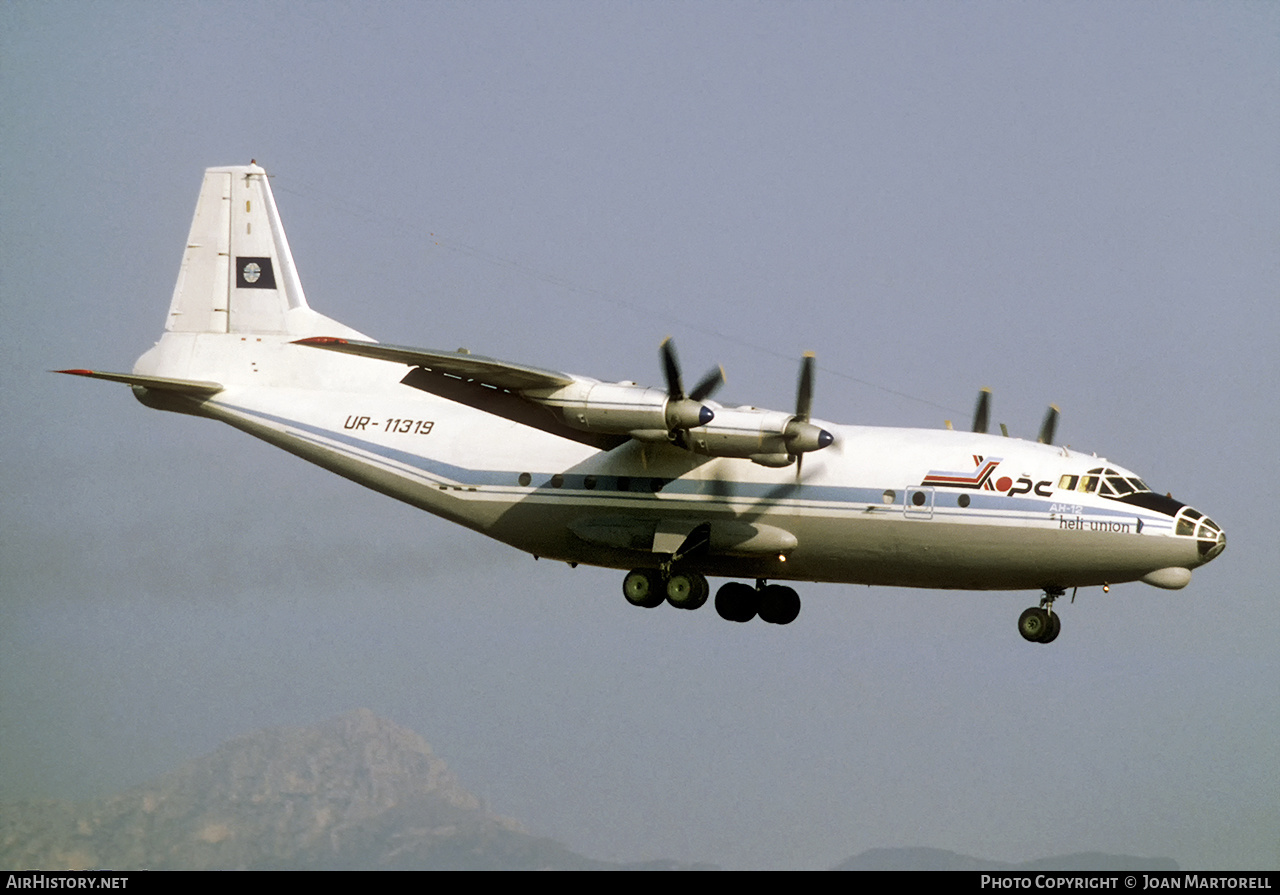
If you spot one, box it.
[0,0,1280,869]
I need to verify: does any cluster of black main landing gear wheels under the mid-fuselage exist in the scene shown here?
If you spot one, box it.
[622,568,800,625]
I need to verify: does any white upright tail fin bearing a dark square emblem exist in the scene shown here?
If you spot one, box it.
[165,164,310,333]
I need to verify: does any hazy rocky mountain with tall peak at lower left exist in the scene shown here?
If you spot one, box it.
[0,709,711,869]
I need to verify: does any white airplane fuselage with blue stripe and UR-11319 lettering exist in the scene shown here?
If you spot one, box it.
[134,330,1225,589]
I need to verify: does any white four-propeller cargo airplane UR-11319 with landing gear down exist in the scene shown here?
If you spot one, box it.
[56,161,1226,643]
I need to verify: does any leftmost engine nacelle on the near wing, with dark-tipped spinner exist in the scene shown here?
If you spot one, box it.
[525,382,716,440]
